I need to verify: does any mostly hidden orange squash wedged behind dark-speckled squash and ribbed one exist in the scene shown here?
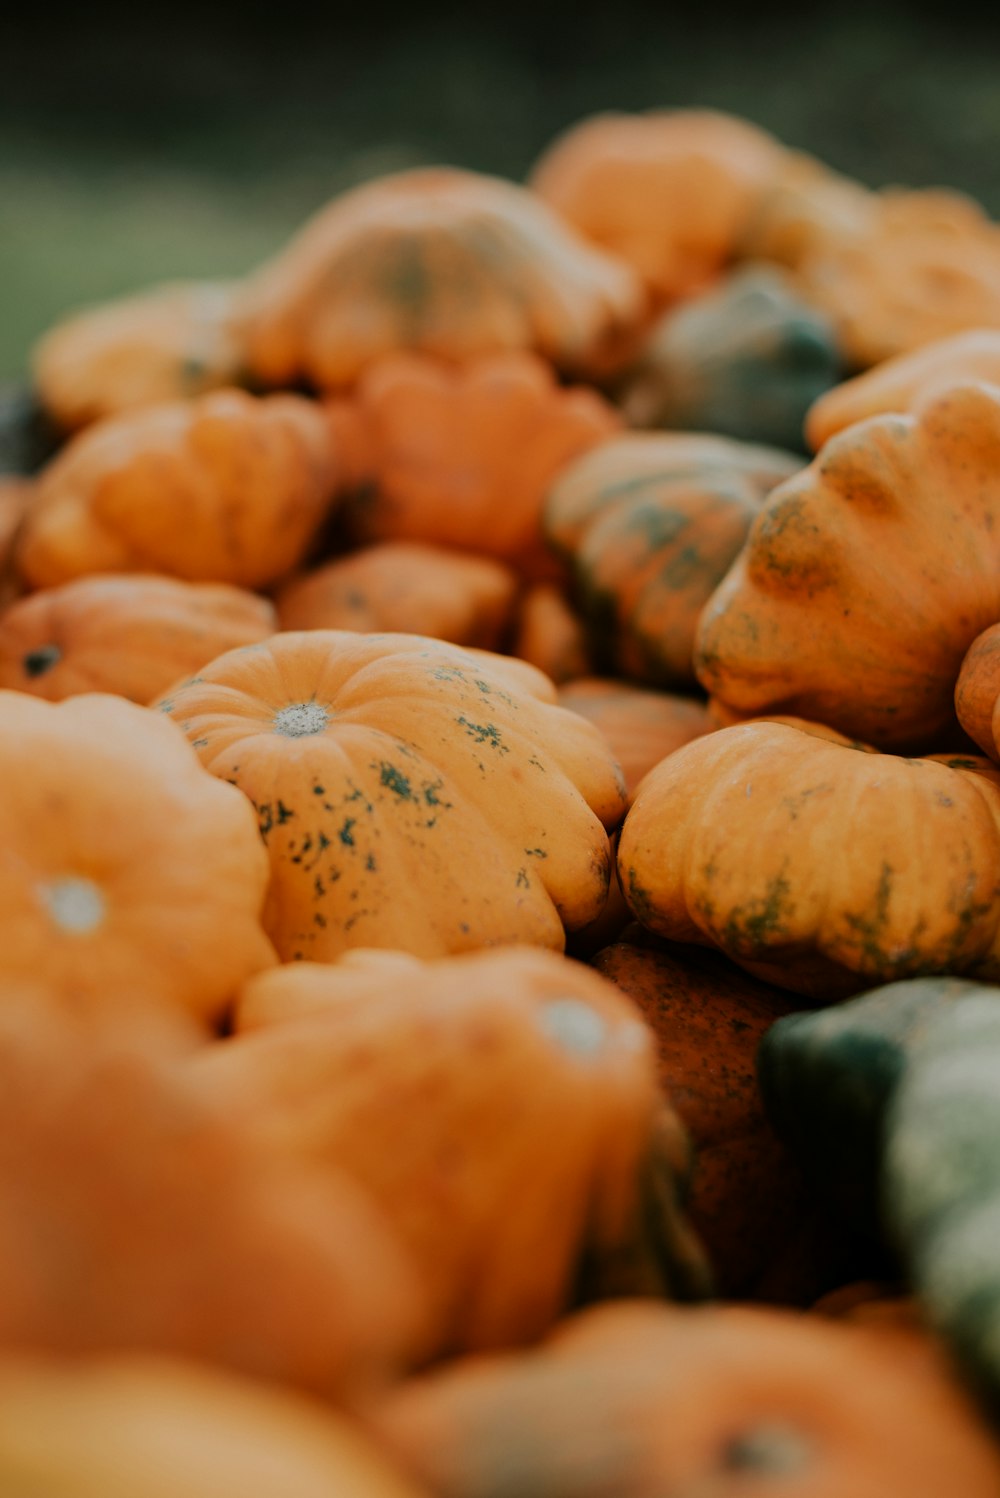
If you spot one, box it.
[558,677,713,795]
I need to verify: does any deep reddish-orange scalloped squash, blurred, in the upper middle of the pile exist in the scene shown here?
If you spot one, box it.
[329,354,620,577]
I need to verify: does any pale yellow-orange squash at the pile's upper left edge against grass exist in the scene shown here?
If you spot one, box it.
[31,282,241,430]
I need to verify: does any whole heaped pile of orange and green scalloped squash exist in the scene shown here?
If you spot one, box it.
[0,111,1000,1498]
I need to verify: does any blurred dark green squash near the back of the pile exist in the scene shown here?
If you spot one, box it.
[618,265,841,448]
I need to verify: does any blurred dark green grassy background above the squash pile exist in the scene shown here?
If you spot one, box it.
[0,0,1000,379]
